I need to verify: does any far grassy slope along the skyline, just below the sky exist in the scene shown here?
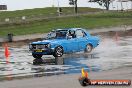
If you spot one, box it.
[0,7,101,19]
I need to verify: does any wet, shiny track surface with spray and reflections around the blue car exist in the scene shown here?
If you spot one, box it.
[0,32,132,80]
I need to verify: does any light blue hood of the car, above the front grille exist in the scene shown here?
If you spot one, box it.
[32,39,66,44]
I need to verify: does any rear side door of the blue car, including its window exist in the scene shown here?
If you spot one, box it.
[76,29,87,51]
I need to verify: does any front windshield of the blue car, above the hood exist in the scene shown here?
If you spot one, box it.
[47,30,67,39]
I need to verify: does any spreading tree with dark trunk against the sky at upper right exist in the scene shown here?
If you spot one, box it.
[89,0,113,10]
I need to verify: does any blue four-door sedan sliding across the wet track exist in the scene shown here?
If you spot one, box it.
[29,28,99,58]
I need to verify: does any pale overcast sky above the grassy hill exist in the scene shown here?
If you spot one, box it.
[0,0,131,10]
